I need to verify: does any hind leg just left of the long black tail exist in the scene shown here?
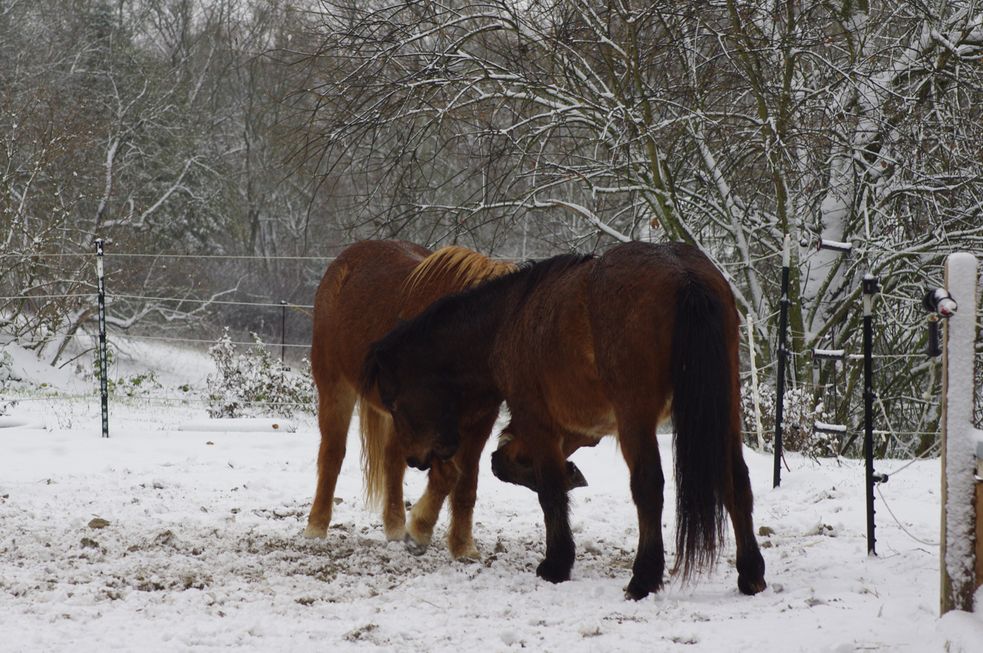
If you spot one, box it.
[618,422,666,601]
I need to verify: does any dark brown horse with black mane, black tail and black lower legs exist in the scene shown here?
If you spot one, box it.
[363,243,765,599]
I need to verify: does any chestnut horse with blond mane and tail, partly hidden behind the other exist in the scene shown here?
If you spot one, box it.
[304,241,515,558]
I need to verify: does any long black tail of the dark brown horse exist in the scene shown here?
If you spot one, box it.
[672,278,736,580]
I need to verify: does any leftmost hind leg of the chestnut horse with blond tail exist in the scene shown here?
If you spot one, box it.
[304,379,356,537]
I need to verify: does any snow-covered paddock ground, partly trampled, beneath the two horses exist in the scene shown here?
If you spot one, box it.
[0,338,983,653]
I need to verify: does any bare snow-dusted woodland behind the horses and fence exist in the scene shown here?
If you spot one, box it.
[0,0,983,456]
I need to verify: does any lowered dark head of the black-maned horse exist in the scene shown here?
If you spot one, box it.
[362,341,460,470]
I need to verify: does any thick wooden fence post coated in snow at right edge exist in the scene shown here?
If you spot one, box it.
[940,253,983,614]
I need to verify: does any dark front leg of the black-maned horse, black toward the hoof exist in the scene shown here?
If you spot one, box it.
[534,442,575,583]
